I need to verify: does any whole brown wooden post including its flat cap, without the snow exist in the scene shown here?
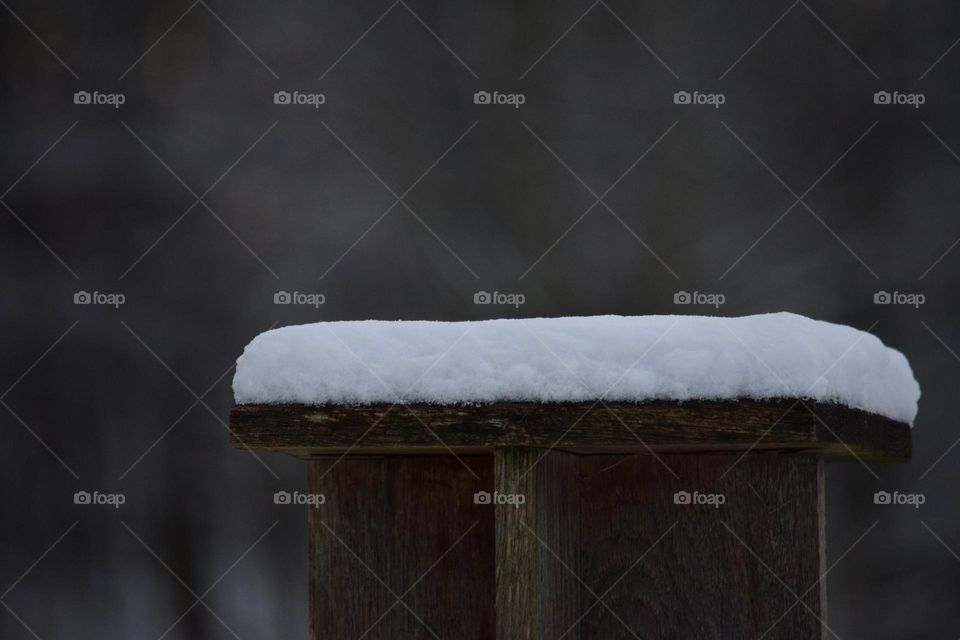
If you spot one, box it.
[231,400,911,640]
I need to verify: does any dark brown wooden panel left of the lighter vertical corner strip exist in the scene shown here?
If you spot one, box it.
[309,456,494,640]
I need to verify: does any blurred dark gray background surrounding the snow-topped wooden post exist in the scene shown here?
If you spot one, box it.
[0,0,960,640]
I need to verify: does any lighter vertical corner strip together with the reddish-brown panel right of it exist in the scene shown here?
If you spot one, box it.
[494,448,826,640]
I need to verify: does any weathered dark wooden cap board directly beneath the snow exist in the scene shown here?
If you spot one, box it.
[230,400,911,461]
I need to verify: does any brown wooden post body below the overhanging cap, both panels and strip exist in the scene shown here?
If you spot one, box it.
[298,447,826,640]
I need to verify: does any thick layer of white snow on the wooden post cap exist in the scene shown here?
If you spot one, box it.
[233,313,920,425]
